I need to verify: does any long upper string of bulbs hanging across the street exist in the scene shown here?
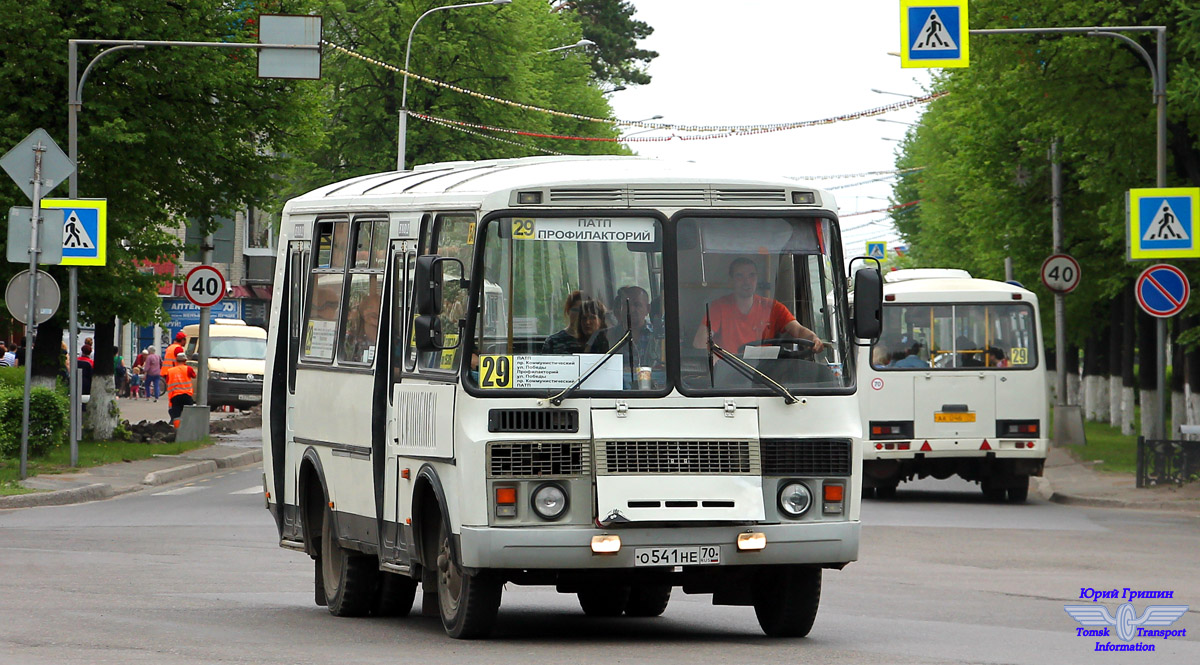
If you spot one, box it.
[320,40,949,133]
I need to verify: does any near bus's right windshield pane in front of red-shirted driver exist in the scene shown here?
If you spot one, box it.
[676,217,852,394]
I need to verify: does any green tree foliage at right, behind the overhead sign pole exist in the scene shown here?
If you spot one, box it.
[894,0,1200,345]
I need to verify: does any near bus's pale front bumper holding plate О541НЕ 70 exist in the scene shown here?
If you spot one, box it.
[458,521,860,570]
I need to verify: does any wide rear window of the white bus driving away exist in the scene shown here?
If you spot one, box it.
[871,302,1038,370]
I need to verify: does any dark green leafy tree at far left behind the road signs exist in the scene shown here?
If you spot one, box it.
[0,0,323,438]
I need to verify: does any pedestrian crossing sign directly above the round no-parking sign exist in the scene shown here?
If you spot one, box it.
[1126,187,1200,260]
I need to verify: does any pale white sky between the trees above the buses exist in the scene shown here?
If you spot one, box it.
[608,0,930,256]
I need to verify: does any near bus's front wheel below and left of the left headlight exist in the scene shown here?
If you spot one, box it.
[436,520,502,640]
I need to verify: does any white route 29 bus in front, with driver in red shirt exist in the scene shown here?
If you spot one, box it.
[263,157,882,637]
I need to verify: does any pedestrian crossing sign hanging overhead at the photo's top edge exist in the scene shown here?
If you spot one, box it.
[900,0,970,67]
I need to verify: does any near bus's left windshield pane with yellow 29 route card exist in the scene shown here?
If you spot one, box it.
[468,216,668,393]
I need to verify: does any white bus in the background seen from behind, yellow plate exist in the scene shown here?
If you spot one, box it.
[858,269,1049,502]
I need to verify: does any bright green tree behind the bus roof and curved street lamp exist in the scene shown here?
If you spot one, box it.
[306,0,625,181]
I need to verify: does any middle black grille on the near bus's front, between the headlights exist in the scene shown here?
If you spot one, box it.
[596,441,760,475]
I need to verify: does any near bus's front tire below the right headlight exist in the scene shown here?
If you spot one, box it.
[754,565,821,637]
